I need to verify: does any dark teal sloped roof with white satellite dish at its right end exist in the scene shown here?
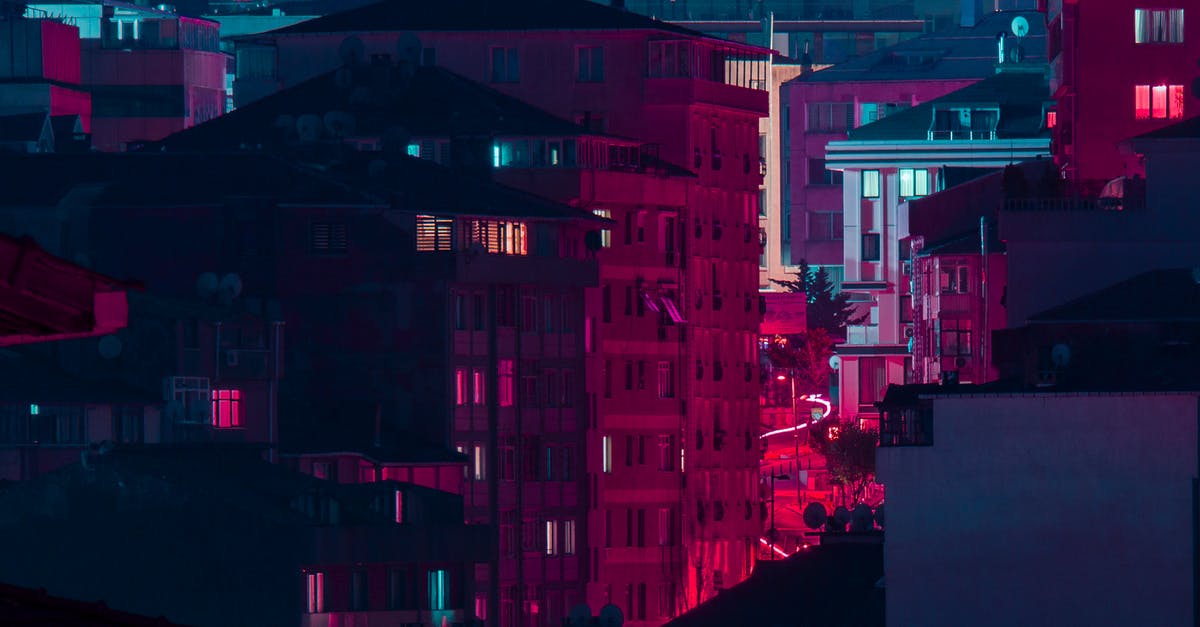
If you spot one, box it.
[793,11,1046,83]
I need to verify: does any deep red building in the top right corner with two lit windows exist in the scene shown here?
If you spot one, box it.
[1046,0,1200,187]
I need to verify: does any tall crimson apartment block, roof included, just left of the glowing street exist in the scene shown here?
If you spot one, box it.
[235,2,767,623]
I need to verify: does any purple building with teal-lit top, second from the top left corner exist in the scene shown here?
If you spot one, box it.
[28,1,226,151]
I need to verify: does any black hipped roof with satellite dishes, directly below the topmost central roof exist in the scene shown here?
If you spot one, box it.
[148,66,609,151]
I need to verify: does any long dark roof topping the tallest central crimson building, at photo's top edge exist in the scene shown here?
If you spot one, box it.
[256,0,710,38]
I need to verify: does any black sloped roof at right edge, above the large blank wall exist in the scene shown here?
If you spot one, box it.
[1030,268,1200,324]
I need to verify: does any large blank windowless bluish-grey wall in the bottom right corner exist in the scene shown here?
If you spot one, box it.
[877,393,1198,626]
